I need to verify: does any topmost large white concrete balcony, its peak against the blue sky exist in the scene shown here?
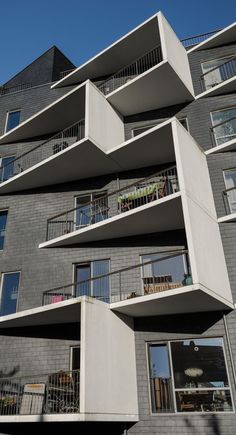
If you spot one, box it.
[53,12,194,115]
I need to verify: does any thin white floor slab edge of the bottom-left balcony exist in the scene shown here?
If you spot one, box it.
[0,413,139,429]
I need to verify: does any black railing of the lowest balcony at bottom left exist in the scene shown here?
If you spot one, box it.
[0,370,80,416]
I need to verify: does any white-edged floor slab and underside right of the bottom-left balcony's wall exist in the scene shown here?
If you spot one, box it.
[110,284,233,317]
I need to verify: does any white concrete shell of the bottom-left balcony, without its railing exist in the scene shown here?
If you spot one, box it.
[0,296,138,423]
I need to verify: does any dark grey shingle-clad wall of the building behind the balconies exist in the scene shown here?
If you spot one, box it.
[0,37,236,435]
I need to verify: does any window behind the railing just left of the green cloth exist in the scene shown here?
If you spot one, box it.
[75,192,108,228]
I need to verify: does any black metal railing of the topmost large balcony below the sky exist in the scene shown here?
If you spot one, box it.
[98,45,162,95]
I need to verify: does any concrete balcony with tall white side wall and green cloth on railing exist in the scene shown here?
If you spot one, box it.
[39,120,232,308]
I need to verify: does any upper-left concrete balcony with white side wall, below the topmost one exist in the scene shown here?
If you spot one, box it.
[0,81,124,194]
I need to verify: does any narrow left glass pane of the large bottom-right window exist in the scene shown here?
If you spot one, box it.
[149,344,173,412]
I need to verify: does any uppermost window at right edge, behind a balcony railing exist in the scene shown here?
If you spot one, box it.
[202,56,235,90]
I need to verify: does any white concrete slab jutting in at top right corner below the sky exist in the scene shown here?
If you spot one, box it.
[188,22,236,53]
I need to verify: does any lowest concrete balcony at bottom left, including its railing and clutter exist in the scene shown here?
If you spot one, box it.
[0,296,138,429]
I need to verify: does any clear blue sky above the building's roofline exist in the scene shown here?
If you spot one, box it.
[0,0,236,84]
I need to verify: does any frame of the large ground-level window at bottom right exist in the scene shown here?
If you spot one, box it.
[145,335,235,417]
